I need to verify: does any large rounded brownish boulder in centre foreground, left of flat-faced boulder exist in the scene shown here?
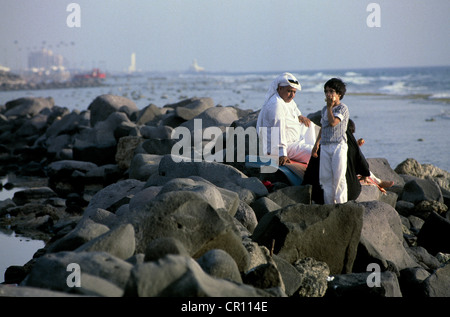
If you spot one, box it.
[121,190,249,271]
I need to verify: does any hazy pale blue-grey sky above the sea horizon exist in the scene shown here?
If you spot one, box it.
[0,0,450,72]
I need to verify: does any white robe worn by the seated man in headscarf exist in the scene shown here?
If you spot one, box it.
[256,93,302,156]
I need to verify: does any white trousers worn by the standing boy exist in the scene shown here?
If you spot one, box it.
[319,142,348,204]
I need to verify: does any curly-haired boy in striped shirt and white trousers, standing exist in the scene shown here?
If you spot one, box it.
[311,78,350,204]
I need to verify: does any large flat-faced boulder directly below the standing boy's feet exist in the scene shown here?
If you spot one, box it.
[252,202,364,274]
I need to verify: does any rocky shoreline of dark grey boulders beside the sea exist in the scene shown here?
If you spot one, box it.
[0,95,450,298]
